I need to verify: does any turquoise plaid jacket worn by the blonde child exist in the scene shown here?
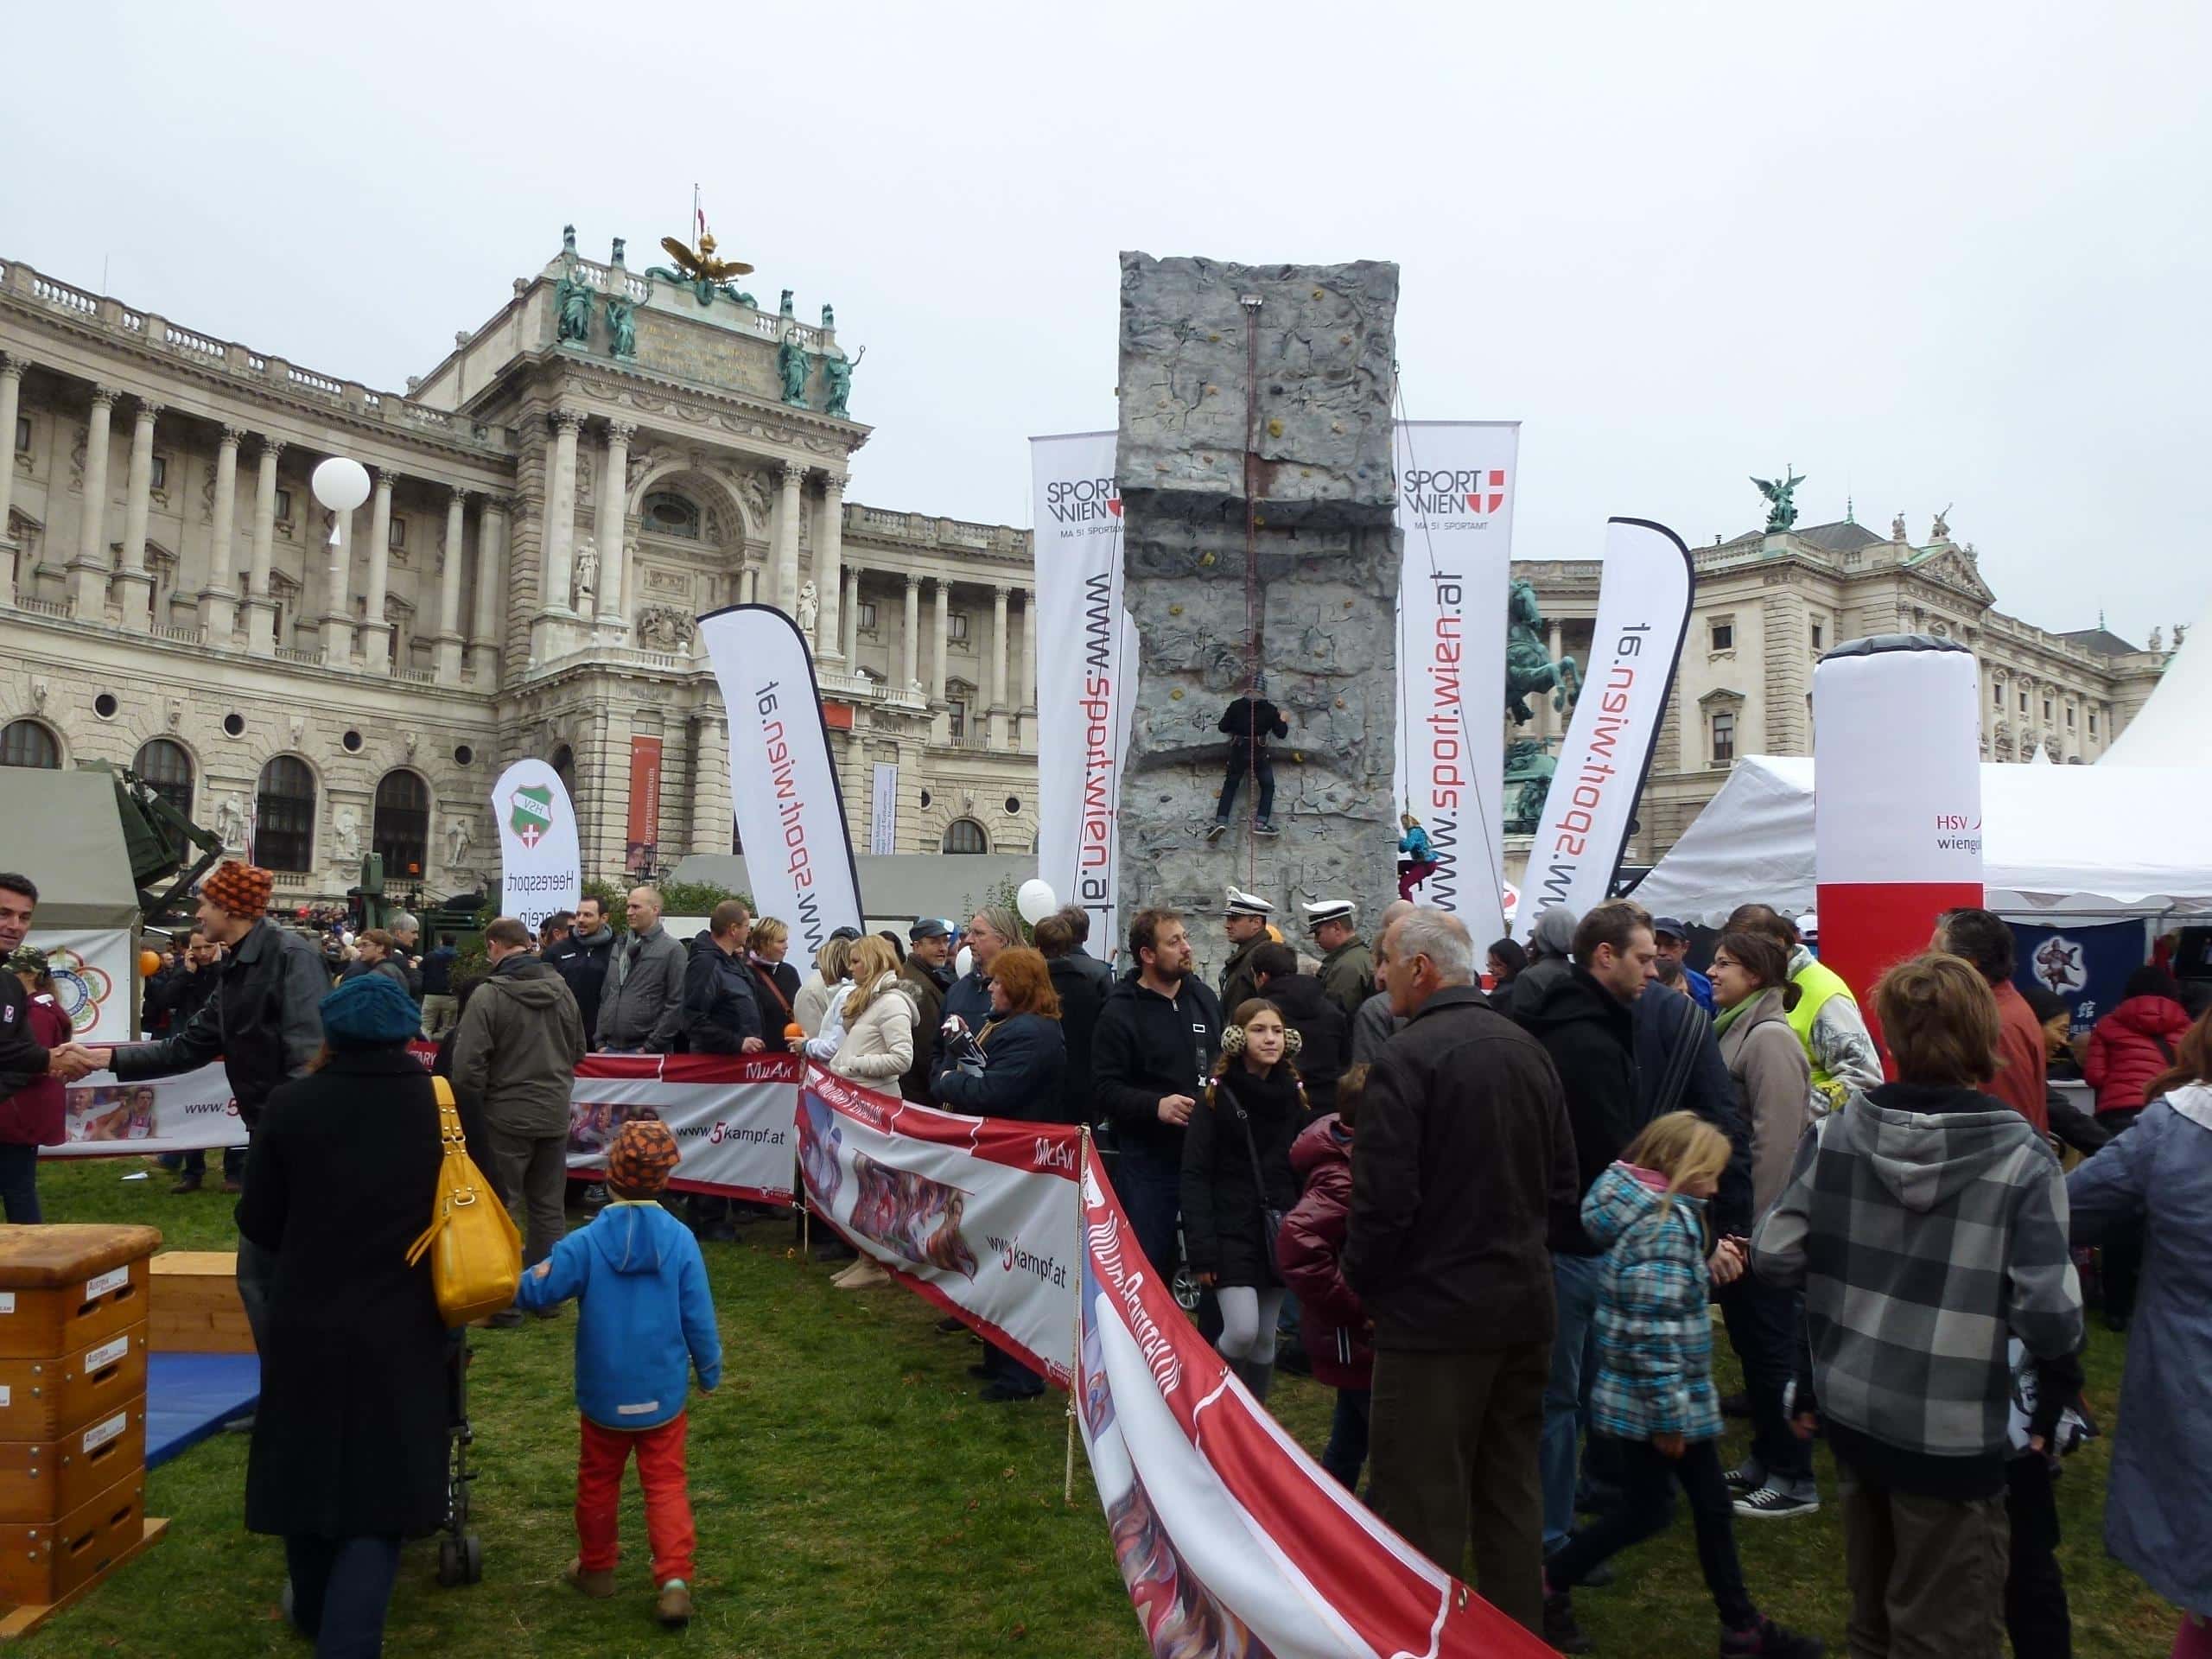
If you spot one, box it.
[1581,1164,1721,1440]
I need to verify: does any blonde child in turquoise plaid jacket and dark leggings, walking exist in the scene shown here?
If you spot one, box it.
[1544,1113,1822,1659]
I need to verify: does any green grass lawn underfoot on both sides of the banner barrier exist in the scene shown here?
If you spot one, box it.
[20,1159,2172,1659]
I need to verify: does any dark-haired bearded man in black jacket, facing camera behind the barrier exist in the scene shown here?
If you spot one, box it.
[1090,909,1221,1276]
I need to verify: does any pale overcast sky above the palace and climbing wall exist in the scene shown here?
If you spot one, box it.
[0,0,2212,641]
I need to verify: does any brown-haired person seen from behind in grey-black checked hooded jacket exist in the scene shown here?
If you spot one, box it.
[1752,953,2082,1659]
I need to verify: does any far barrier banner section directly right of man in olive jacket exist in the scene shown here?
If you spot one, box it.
[569,1055,801,1204]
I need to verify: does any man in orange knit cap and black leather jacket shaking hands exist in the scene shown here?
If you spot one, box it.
[93,858,329,1347]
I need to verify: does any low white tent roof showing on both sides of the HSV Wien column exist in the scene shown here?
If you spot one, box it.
[1635,754,2212,923]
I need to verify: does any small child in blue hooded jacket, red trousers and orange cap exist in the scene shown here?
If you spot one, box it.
[515,1117,721,1628]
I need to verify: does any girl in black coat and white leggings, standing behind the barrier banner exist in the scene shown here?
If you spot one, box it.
[1184,998,1307,1400]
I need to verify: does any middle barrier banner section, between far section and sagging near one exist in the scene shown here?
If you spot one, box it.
[798,1064,1084,1387]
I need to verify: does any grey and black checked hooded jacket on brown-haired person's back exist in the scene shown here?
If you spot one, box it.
[1752,1084,2082,1458]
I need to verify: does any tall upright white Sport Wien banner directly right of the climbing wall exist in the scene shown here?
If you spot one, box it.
[1391,420,1520,940]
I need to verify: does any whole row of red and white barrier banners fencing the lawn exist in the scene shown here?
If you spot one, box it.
[47,1055,1548,1659]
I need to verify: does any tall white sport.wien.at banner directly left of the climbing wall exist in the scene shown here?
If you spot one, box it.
[1028,431,1137,960]
